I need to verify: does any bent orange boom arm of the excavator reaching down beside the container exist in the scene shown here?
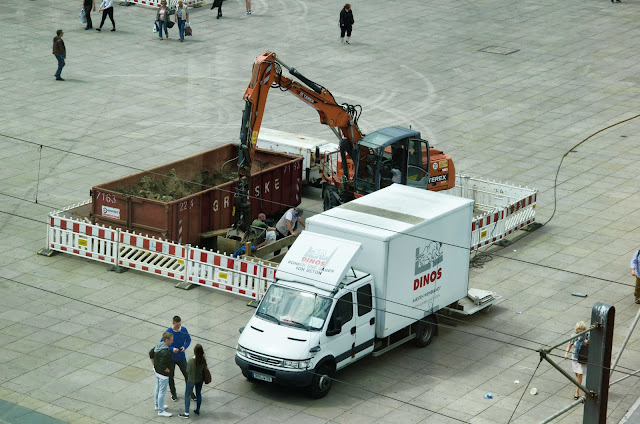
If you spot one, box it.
[235,51,363,233]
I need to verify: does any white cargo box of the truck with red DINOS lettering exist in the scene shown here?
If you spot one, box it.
[306,184,473,337]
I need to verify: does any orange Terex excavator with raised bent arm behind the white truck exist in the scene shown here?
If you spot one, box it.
[235,51,455,233]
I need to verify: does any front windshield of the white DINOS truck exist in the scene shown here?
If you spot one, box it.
[256,284,332,331]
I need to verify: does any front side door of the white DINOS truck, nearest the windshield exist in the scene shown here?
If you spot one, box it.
[327,293,356,369]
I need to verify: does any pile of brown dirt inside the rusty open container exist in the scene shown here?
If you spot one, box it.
[115,168,238,202]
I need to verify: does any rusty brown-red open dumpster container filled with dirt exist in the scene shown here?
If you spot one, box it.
[91,143,303,245]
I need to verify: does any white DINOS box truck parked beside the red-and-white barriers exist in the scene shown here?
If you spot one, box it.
[236,184,473,398]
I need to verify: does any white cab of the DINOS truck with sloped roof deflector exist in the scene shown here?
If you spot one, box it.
[236,232,376,398]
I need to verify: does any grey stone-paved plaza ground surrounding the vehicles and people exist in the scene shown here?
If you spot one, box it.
[0,0,640,424]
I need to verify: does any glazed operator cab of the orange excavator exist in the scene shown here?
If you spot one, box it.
[353,127,430,195]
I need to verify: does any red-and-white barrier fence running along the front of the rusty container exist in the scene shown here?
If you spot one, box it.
[47,200,275,300]
